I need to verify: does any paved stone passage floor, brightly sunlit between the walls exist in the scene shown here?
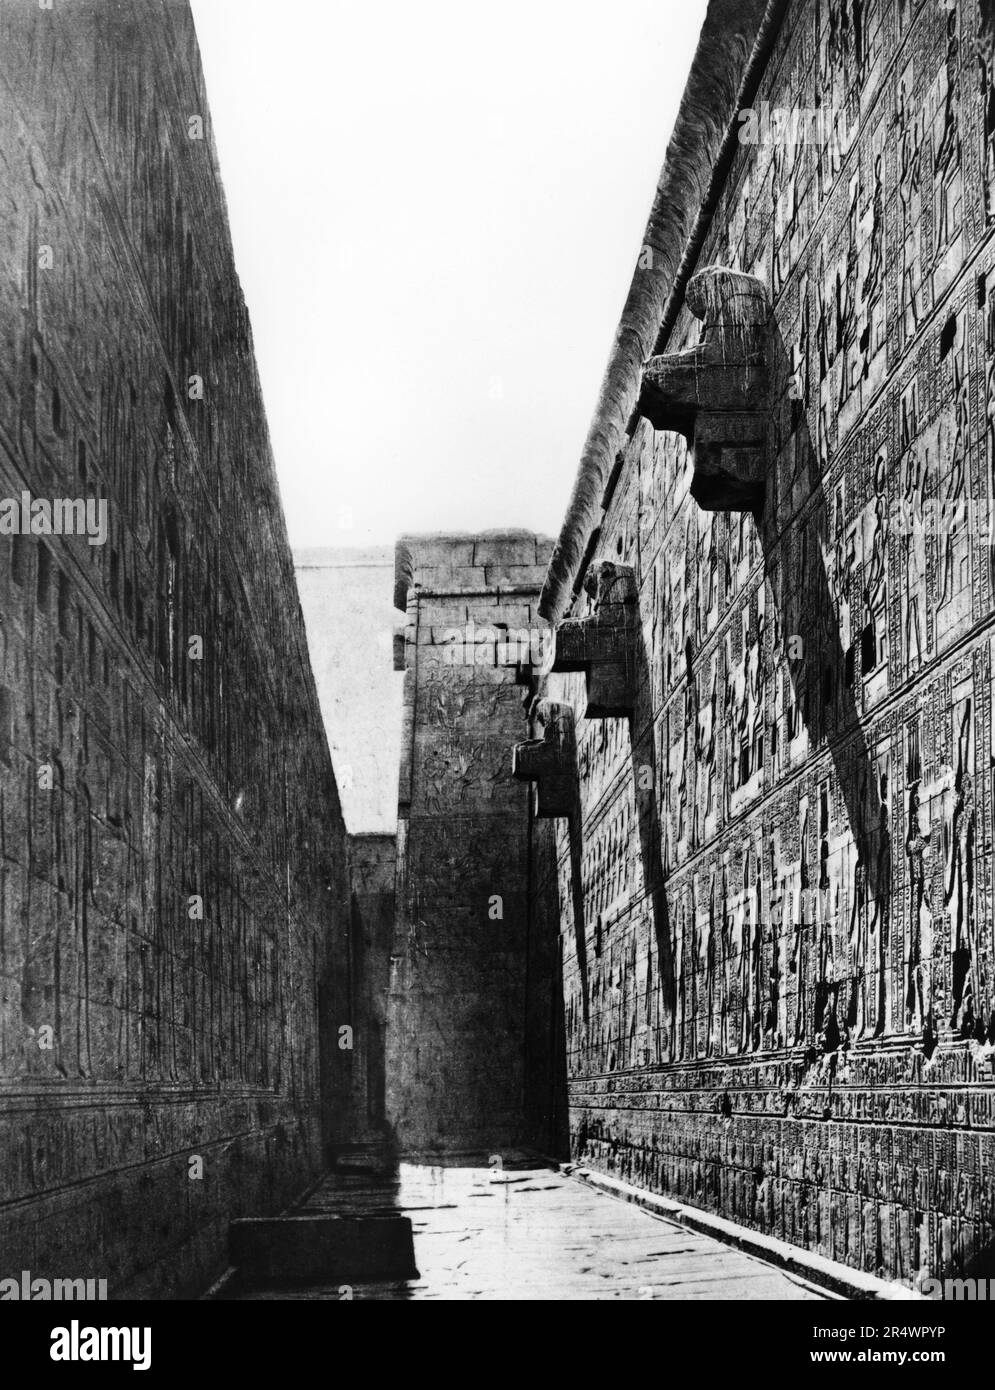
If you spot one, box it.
[230,1161,831,1301]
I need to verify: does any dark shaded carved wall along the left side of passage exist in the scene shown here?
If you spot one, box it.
[0,0,347,1297]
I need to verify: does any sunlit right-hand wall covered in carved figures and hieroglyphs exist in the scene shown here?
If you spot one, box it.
[534,0,995,1283]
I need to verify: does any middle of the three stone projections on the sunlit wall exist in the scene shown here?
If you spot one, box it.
[552,560,639,719]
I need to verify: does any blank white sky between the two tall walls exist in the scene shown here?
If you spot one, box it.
[192,0,705,548]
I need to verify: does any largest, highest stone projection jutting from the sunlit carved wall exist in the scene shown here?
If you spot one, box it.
[638,265,770,512]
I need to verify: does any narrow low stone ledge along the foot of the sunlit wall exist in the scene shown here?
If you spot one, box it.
[556,1163,928,1302]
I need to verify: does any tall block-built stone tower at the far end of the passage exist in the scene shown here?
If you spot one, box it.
[388,531,557,1151]
